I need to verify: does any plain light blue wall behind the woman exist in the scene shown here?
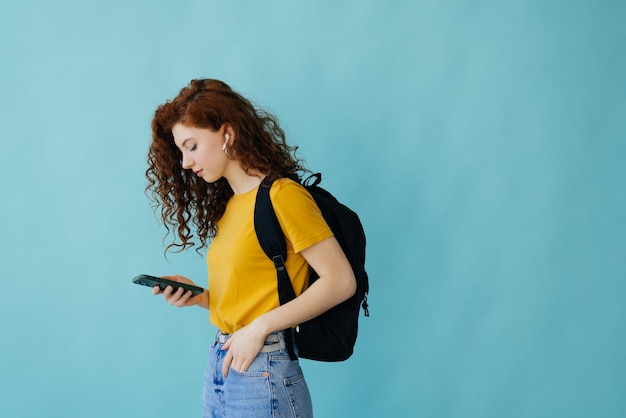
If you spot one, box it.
[0,0,626,418]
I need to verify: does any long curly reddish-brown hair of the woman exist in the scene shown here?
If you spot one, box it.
[146,79,308,253]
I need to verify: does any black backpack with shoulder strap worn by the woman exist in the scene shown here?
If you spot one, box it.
[254,173,369,361]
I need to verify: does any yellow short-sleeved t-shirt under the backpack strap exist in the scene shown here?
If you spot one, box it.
[207,179,333,334]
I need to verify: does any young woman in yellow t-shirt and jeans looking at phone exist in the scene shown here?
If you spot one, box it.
[146,79,356,417]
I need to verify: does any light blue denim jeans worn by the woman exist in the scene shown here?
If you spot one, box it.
[202,332,313,418]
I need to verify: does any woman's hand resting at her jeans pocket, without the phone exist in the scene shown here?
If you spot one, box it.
[222,322,268,377]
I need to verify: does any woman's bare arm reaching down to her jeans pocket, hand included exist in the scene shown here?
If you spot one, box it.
[222,237,356,376]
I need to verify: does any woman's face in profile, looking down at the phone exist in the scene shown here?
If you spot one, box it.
[172,123,232,183]
